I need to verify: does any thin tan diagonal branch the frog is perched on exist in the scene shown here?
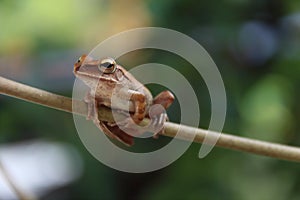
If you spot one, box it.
[0,77,300,162]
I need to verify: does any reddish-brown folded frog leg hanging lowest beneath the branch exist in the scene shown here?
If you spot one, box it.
[99,121,134,146]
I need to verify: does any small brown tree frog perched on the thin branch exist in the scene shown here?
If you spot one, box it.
[73,55,174,146]
